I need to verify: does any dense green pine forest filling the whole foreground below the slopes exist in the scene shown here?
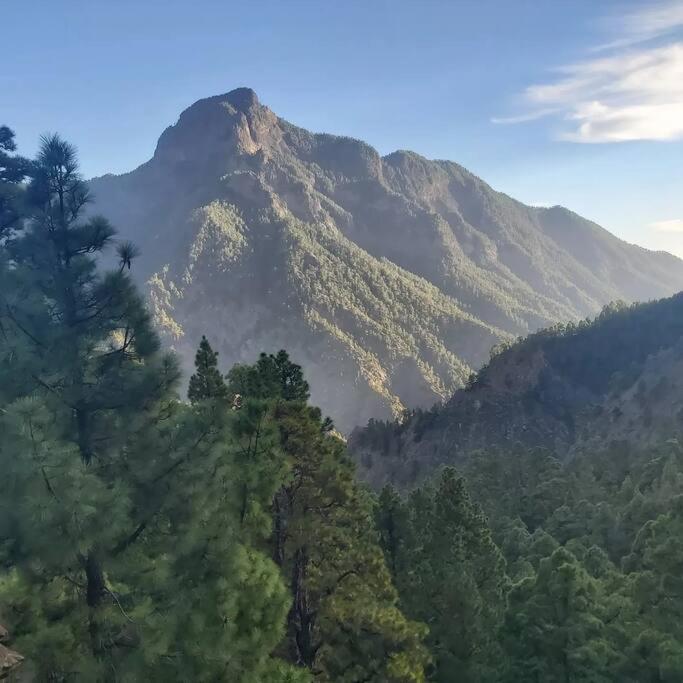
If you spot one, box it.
[0,128,683,683]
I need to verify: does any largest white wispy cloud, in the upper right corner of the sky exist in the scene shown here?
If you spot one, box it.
[492,0,683,143]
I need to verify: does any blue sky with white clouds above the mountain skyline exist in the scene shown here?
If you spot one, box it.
[0,0,683,256]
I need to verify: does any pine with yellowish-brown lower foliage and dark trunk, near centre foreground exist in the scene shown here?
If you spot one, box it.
[230,352,426,683]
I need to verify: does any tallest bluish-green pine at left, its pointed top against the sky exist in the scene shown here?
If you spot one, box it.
[0,136,178,675]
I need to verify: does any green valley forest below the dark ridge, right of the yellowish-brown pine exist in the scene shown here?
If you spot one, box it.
[376,442,683,683]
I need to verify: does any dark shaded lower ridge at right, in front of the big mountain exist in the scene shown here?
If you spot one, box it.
[349,293,683,487]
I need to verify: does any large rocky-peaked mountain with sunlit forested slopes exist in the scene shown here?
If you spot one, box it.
[90,88,683,430]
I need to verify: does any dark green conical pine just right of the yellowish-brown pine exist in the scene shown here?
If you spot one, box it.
[380,469,507,682]
